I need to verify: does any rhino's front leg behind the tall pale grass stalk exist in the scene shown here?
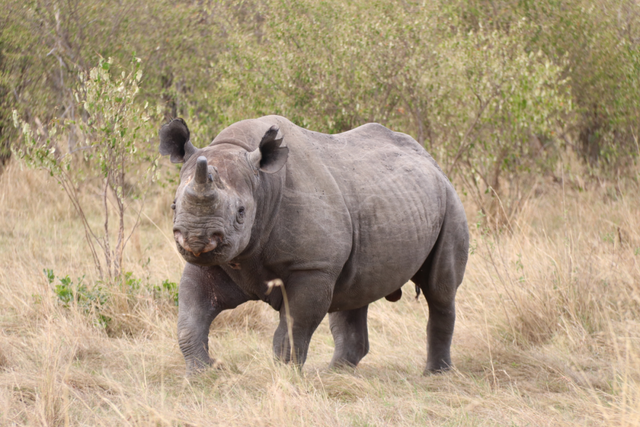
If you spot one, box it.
[273,272,335,366]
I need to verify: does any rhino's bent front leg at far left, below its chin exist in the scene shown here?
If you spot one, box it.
[178,264,247,374]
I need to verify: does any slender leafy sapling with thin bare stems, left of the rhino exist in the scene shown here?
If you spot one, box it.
[14,58,157,279]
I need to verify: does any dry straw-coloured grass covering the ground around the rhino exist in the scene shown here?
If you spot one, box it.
[0,164,640,426]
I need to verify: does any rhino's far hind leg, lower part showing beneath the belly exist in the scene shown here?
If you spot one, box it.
[329,305,369,368]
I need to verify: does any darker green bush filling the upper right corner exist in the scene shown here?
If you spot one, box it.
[450,0,640,173]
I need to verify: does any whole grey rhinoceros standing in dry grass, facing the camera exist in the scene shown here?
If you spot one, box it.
[159,116,469,373]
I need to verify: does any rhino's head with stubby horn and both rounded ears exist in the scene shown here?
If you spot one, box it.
[159,118,289,266]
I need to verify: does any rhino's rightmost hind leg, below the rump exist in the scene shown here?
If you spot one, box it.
[412,197,469,374]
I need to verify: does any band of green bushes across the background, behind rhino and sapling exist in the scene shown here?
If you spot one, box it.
[0,0,640,219]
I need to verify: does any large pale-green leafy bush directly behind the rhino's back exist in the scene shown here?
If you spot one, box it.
[213,1,572,221]
